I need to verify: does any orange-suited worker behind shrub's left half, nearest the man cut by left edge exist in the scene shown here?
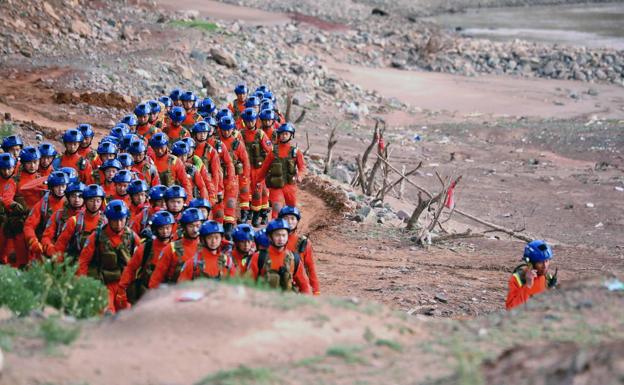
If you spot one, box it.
[24,171,69,261]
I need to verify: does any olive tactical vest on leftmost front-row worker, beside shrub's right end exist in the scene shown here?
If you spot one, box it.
[95,226,135,284]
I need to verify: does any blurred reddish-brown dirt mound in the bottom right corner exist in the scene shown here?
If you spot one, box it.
[483,340,624,385]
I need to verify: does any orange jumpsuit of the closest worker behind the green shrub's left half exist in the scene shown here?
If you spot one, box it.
[24,192,65,261]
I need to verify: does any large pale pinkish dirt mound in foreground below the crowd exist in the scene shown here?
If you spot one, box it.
[2,282,414,385]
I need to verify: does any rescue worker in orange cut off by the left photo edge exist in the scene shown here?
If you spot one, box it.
[0,153,28,267]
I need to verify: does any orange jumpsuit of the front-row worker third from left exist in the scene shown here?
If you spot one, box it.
[149,237,199,289]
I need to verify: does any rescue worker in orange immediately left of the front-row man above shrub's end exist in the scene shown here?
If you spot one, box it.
[48,184,106,263]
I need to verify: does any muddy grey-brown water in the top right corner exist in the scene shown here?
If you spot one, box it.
[427,2,624,49]
